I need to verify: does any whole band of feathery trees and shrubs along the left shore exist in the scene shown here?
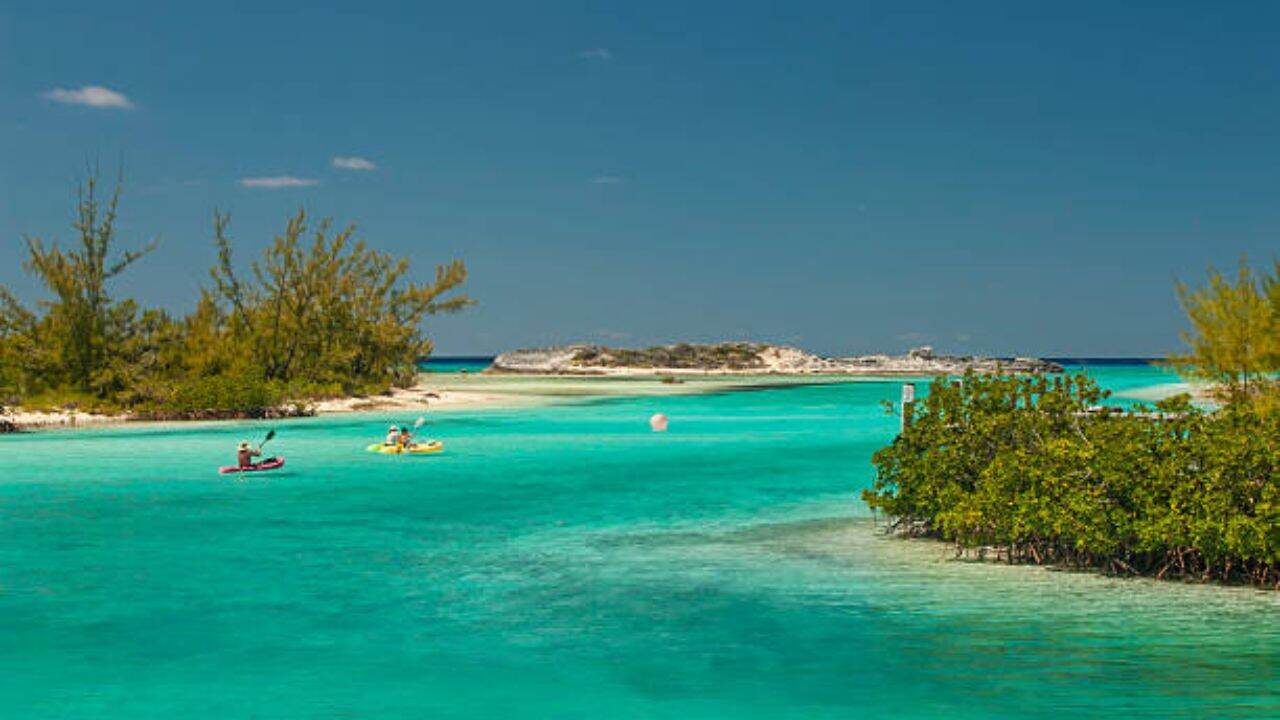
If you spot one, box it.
[0,173,471,418]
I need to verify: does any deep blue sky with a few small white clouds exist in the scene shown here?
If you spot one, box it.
[0,1,1280,355]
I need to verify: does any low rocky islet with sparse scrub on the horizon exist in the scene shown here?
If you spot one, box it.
[485,342,1062,375]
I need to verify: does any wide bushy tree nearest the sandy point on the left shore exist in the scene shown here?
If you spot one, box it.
[204,210,472,392]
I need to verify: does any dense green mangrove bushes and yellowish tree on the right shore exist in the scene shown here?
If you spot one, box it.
[863,260,1280,588]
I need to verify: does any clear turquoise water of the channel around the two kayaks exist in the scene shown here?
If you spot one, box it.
[0,368,1280,719]
